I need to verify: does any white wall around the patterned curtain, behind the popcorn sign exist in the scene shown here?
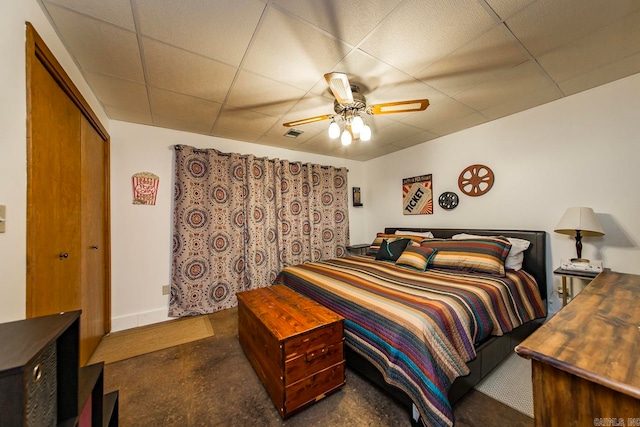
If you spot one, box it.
[111,121,366,331]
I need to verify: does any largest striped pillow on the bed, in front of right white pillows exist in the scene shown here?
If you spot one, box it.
[422,237,511,276]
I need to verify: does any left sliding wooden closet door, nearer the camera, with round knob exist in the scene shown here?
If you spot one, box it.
[27,55,81,317]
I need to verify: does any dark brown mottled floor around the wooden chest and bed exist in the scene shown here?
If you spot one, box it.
[105,309,533,427]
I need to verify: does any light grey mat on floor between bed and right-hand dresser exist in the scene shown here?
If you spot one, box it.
[475,353,533,418]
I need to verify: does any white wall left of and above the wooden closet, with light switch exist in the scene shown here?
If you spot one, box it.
[0,0,108,322]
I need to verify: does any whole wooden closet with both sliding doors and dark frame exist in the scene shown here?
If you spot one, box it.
[26,21,111,365]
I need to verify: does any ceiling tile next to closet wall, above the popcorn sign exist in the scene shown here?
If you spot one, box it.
[85,73,149,113]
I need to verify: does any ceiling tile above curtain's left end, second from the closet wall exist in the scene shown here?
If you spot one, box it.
[149,87,221,126]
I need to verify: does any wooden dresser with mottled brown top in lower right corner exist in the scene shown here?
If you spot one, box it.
[516,271,640,427]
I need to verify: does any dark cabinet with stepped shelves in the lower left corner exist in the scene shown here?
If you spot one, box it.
[0,311,118,427]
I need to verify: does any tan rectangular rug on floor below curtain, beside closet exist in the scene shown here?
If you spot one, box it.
[88,315,213,364]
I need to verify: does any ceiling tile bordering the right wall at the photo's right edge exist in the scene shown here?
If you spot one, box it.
[558,53,640,95]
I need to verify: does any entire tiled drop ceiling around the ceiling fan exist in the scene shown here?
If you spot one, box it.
[39,0,640,161]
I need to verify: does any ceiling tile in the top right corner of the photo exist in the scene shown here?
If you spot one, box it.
[506,0,640,57]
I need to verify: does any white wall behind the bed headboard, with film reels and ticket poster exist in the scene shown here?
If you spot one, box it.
[362,74,640,312]
